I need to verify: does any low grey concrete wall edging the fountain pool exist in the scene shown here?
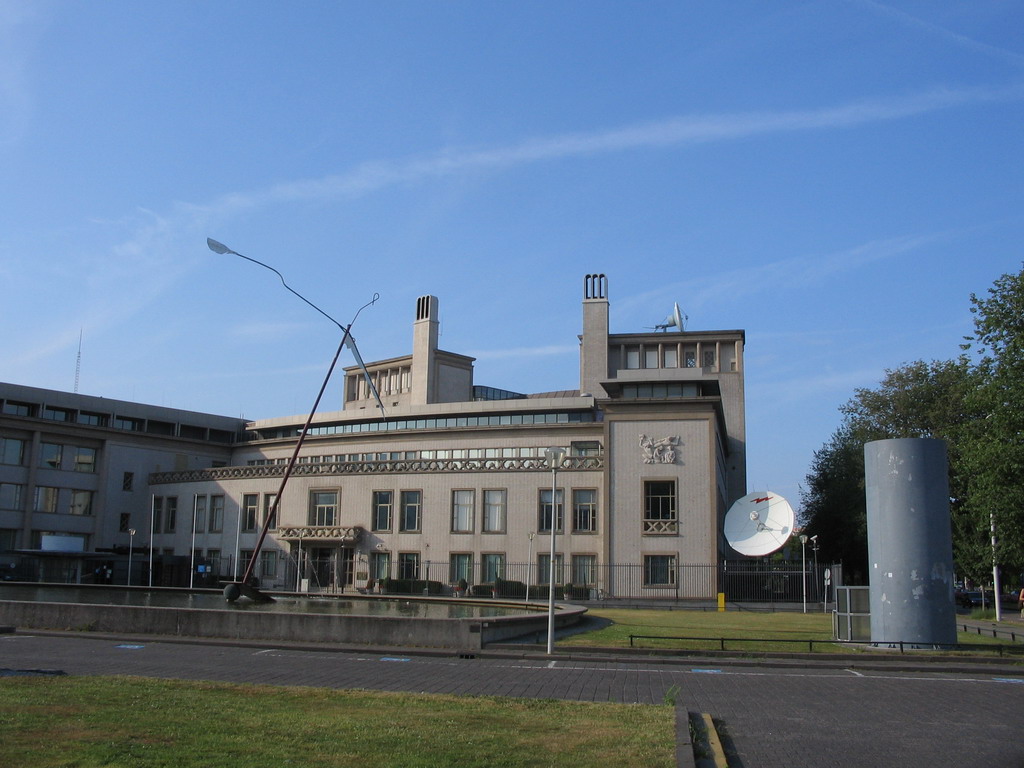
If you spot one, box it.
[0,600,586,651]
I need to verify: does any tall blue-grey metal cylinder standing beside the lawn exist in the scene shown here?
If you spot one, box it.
[864,438,956,646]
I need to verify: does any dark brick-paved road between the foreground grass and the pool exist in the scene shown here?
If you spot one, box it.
[0,634,1024,768]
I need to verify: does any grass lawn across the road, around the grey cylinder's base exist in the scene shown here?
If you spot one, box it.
[558,608,1009,653]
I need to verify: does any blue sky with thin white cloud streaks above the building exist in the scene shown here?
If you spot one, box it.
[0,0,1024,506]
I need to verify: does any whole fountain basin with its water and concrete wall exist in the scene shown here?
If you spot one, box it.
[0,584,586,651]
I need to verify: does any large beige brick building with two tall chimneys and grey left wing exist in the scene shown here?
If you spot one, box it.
[0,274,746,598]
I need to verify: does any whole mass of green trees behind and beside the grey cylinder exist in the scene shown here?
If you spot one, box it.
[802,262,1024,584]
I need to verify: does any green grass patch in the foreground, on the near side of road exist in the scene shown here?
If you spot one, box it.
[0,677,675,768]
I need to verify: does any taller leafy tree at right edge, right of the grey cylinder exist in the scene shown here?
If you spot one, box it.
[958,270,1024,585]
